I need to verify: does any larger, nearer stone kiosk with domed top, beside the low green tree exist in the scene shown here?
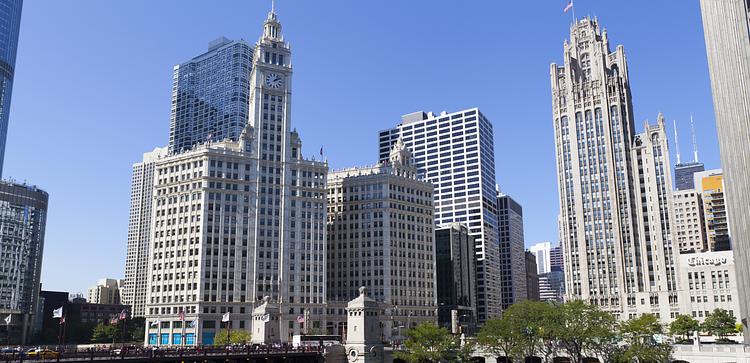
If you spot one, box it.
[346,286,384,363]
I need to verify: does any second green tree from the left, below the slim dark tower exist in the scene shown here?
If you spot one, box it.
[477,314,523,359]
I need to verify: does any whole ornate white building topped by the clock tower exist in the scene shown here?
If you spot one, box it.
[146,12,328,345]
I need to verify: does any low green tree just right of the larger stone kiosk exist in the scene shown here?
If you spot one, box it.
[395,323,459,363]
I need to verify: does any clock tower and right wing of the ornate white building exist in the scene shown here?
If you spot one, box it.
[246,4,328,341]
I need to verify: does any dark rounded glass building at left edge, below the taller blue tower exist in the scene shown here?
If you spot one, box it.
[0,181,49,344]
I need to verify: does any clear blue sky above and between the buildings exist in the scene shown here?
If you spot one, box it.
[4,0,719,292]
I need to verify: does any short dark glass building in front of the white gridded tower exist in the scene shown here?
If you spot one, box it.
[435,223,476,332]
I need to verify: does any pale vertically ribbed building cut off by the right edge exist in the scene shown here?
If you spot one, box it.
[701,0,750,343]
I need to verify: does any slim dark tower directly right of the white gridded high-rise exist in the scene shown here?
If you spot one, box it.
[497,194,536,310]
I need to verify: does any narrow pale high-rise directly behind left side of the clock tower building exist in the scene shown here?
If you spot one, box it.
[120,147,168,317]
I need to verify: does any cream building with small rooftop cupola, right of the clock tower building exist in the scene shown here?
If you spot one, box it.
[326,142,437,333]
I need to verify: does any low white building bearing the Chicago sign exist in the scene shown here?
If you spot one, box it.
[679,251,739,322]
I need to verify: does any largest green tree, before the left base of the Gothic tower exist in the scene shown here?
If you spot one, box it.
[557,300,618,363]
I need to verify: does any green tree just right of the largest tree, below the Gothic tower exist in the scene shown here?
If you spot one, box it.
[615,314,672,363]
